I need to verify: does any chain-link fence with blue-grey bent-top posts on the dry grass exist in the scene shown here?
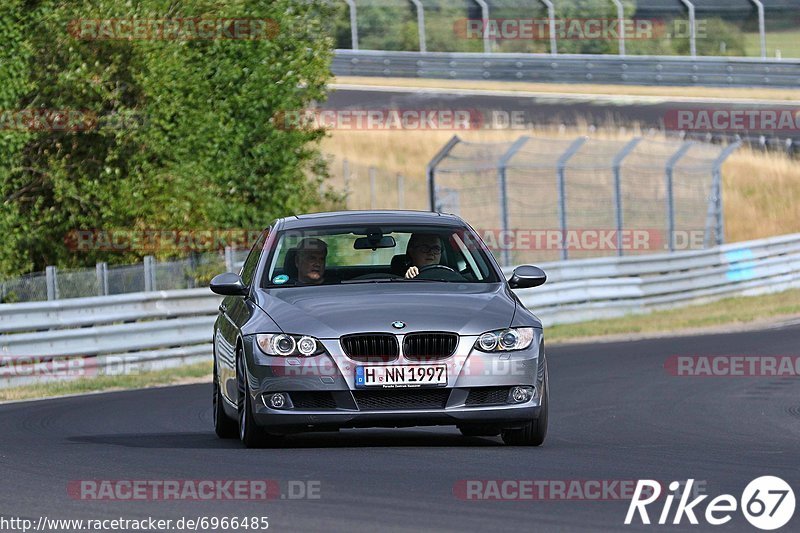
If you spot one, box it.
[428,133,739,266]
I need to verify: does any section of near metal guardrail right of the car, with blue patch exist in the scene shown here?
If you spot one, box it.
[506,234,800,324]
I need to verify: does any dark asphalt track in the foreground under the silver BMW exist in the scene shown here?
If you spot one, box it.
[0,326,800,531]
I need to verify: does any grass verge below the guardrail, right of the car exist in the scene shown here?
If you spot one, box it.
[545,289,800,343]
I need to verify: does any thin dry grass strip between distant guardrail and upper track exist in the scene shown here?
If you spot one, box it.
[333,76,797,100]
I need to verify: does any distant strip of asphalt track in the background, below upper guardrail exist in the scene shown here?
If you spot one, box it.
[321,86,800,150]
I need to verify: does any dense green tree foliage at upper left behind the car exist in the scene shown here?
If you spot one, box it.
[0,0,335,275]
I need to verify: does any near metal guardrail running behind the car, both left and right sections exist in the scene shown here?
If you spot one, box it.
[0,234,800,388]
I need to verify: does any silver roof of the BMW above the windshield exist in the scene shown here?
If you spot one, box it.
[280,210,466,229]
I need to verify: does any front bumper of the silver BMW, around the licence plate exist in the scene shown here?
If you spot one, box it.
[245,332,546,432]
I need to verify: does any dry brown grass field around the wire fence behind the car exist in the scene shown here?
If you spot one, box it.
[322,126,800,242]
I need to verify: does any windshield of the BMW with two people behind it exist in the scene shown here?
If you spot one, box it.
[261,226,500,288]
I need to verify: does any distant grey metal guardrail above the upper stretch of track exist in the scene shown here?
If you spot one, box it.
[332,49,800,88]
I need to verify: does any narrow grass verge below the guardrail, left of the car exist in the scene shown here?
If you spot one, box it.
[0,361,211,401]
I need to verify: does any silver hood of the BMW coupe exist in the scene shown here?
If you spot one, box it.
[256,282,520,339]
